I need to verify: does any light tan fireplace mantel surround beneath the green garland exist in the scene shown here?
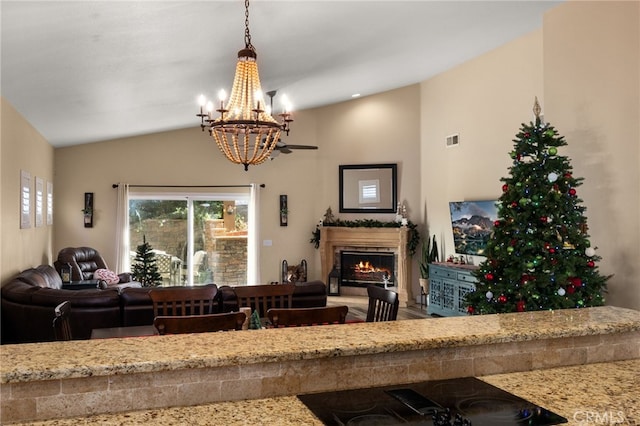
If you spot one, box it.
[320,226,413,307]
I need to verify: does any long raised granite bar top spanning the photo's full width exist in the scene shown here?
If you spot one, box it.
[0,306,640,383]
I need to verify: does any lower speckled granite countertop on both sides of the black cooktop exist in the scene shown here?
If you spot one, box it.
[10,359,640,426]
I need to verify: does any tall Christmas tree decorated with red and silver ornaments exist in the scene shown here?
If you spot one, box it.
[466,99,608,314]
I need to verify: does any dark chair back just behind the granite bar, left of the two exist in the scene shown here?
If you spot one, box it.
[153,312,246,334]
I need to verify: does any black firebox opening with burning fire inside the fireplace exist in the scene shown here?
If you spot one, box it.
[340,250,395,287]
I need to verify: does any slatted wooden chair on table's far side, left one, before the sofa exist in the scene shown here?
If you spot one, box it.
[149,284,218,318]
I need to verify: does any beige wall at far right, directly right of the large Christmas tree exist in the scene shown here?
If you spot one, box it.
[544,1,640,309]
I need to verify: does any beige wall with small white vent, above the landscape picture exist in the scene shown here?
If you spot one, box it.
[421,31,543,264]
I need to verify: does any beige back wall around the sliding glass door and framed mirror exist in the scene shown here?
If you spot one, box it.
[54,85,419,285]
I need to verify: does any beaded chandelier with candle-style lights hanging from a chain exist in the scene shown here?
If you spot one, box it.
[196,0,293,170]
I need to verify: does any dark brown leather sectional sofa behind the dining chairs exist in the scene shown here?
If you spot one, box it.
[0,265,327,344]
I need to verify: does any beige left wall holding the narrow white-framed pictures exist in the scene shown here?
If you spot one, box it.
[0,98,56,282]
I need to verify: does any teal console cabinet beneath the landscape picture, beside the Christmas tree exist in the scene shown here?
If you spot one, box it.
[427,263,477,317]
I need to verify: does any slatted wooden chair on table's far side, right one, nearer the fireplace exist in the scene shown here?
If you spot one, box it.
[234,284,296,318]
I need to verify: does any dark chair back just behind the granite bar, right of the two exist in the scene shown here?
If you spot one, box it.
[267,305,349,328]
